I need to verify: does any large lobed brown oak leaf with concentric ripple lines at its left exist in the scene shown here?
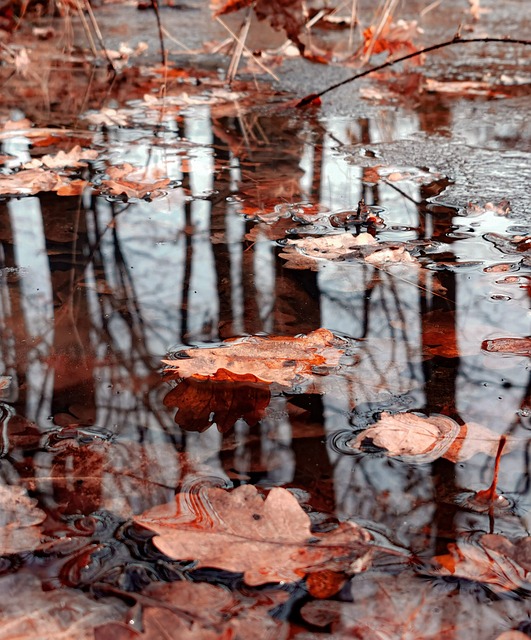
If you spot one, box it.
[135,485,370,586]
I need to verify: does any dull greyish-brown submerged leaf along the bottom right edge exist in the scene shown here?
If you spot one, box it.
[301,571,530,640]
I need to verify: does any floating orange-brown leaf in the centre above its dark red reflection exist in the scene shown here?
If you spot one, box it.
[163,329,352,389]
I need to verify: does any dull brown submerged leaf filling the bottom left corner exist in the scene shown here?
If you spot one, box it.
[0,573,127,640]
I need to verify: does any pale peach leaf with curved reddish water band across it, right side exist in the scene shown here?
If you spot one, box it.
[349,411,513,464]
